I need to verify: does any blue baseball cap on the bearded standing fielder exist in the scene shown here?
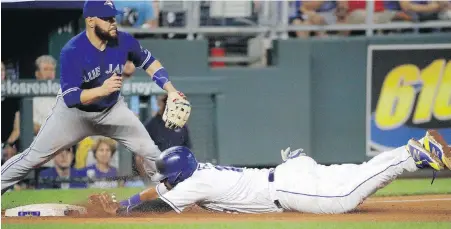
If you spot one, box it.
[83,0,122,18]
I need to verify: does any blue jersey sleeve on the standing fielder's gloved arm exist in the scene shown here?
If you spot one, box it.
[124,33,155,70]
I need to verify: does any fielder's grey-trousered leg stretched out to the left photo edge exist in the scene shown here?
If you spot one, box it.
[1,97,92,193]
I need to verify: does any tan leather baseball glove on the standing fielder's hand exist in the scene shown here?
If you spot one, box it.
[163,91,191,129]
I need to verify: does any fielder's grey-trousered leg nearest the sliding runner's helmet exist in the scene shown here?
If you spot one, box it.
[97,99,161,175]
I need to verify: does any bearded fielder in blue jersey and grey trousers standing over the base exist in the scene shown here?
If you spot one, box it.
[1,0,191,194]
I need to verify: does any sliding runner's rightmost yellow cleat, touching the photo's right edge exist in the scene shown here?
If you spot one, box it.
[423,130,451,170]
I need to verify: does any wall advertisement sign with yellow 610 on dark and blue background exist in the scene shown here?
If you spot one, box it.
[366,44,451,156]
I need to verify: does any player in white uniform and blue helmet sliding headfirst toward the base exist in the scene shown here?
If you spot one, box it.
[90,131,451,215]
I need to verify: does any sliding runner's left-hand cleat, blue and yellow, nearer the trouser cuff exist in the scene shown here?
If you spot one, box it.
[406,138,444,171]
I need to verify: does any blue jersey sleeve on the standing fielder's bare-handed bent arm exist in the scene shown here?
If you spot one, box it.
[60,49,83,108]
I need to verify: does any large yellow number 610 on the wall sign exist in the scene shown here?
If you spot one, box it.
[375,59,451,130]
